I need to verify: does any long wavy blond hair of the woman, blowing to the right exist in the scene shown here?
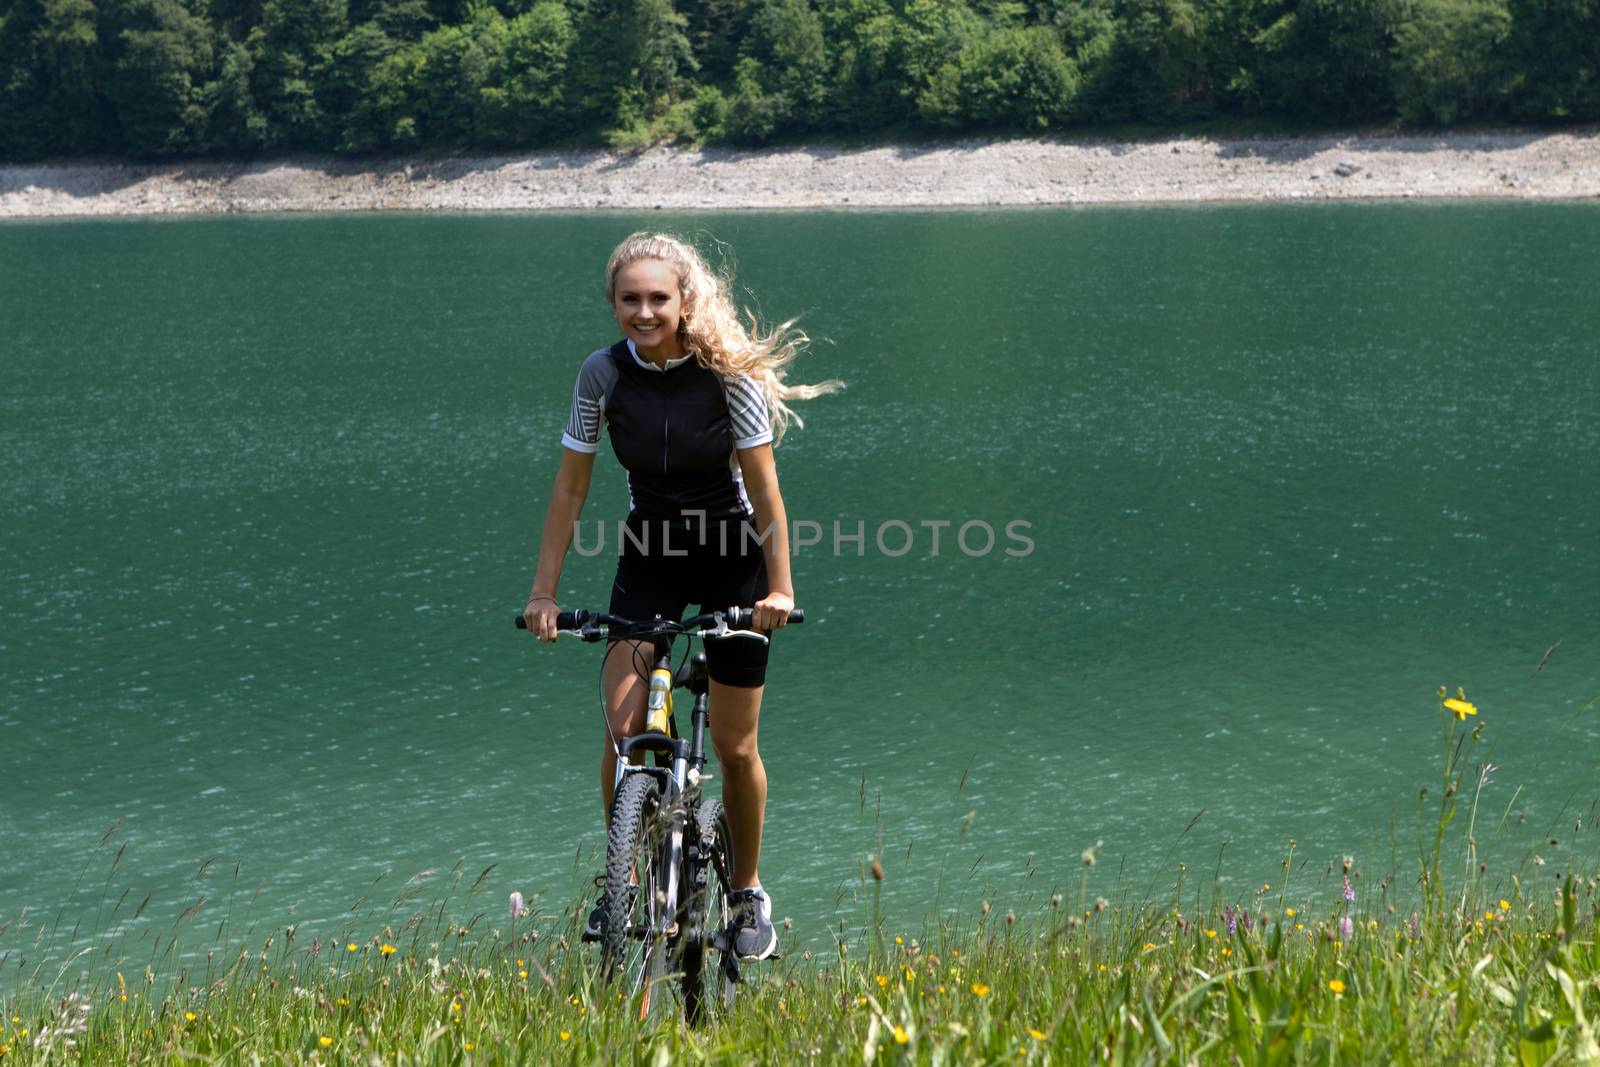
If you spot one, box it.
[605,230,845,446]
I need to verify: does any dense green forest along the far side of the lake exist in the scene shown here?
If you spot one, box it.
[0,0,1600,162]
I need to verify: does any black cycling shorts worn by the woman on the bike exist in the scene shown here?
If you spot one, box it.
[610,515,766,689]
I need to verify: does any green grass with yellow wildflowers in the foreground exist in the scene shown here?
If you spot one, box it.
[0,693,1600,1067]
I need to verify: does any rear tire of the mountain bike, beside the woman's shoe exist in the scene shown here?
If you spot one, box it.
[680,800,739,1025]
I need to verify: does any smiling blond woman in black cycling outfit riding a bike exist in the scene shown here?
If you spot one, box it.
[523,232,838,960]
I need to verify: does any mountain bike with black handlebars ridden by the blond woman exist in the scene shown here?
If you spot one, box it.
[517,608,805,1024]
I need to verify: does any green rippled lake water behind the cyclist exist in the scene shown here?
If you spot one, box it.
[0,203,1600,979]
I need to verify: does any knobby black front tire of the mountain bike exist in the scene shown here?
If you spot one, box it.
[600,774,670,1021]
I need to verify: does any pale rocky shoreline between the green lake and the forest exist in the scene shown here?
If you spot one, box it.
[0,130,1600,219]
